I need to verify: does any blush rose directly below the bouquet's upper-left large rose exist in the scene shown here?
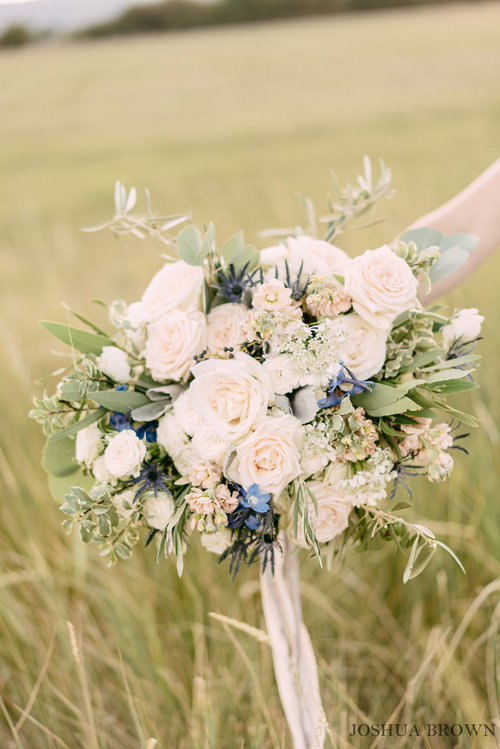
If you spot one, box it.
[144,310,206,382]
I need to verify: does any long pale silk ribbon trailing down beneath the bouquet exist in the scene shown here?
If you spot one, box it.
[261,535,327,749]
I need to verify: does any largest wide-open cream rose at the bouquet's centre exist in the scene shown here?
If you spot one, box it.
[189,353,273,442]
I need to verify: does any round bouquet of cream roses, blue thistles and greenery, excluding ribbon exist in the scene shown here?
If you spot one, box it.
[32,160,483,581]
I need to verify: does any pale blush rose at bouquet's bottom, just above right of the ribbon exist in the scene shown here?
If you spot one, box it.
[297,481,352,546]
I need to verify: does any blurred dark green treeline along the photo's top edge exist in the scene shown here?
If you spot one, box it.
[77,0,460,37]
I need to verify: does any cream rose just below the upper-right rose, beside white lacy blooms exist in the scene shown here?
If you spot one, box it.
[331,312,388,380]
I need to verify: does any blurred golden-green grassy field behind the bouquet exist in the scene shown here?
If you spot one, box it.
[0,3,500,749]
